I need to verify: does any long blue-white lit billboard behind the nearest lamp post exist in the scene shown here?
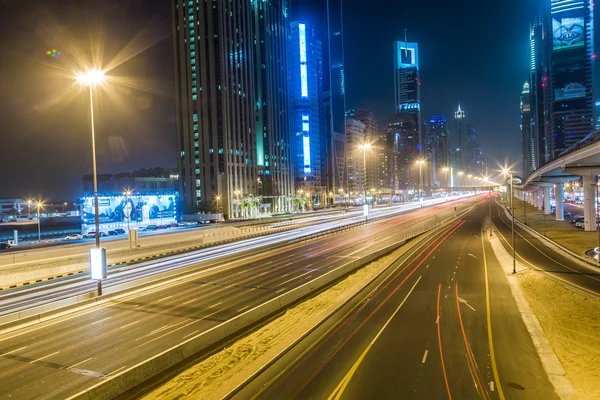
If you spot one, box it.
[81,193,178,232]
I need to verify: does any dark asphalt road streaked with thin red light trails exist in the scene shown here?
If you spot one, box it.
[234,205,558,400]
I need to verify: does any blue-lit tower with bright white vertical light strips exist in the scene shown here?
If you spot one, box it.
[288,22,326,195]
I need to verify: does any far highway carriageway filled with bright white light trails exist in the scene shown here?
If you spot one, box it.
[0,195,472,316]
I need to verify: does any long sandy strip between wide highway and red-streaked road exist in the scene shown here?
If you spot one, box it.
[143,246,406,400]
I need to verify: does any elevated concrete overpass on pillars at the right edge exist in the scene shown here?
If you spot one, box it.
[514,131,600,231]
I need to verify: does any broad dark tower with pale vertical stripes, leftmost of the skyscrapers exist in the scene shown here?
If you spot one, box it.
[171,0,258,215]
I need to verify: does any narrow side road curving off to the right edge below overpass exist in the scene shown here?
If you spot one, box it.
[492,202,600,298]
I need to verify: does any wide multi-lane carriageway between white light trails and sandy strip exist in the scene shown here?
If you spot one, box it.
[0,198,480,399]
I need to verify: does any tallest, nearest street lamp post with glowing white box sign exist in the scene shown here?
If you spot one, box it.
[77,68,106,296]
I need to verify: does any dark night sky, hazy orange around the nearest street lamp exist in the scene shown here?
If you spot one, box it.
[0,0,534,200]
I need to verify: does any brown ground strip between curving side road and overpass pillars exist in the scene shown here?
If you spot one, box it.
[502,198,598,254]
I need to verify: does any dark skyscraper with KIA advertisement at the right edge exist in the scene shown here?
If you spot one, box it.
[549,0,596,158]
